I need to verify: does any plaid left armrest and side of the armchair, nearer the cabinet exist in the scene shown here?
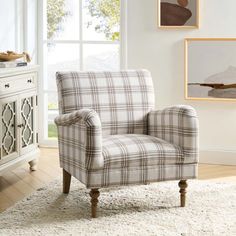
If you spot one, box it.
[55,109,104,170]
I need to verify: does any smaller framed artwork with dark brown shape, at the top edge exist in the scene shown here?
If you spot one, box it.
[158,0,199,29]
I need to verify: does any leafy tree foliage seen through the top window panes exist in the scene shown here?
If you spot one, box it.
[47,0,120,41]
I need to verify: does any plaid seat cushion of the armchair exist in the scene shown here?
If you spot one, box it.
[102,134,189,169]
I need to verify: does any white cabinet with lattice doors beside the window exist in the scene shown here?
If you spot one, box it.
[0,66,39,174]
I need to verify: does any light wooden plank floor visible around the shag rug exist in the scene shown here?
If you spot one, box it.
[0,149,236,212]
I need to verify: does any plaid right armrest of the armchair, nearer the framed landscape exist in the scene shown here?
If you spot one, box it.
[148,105,199,162]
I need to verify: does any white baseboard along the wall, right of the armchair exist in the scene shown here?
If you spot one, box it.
[200,150,236,165]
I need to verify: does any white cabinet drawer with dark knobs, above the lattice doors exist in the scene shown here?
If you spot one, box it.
[0,73,37,95]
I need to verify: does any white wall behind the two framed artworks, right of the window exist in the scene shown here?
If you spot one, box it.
[127,0,236,164]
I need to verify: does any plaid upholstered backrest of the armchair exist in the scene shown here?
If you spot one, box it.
[57,70,154,135]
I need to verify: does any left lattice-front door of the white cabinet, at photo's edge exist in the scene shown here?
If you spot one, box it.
[0,101,17,159]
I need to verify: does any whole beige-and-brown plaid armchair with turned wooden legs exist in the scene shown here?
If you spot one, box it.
[55,70,198,217]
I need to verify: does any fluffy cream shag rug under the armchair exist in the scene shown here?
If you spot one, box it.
[0,180,236,236]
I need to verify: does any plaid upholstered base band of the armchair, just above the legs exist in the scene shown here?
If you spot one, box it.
[64,164,198,188]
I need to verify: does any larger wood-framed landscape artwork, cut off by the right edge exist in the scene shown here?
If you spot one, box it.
[185,38,236,101]
